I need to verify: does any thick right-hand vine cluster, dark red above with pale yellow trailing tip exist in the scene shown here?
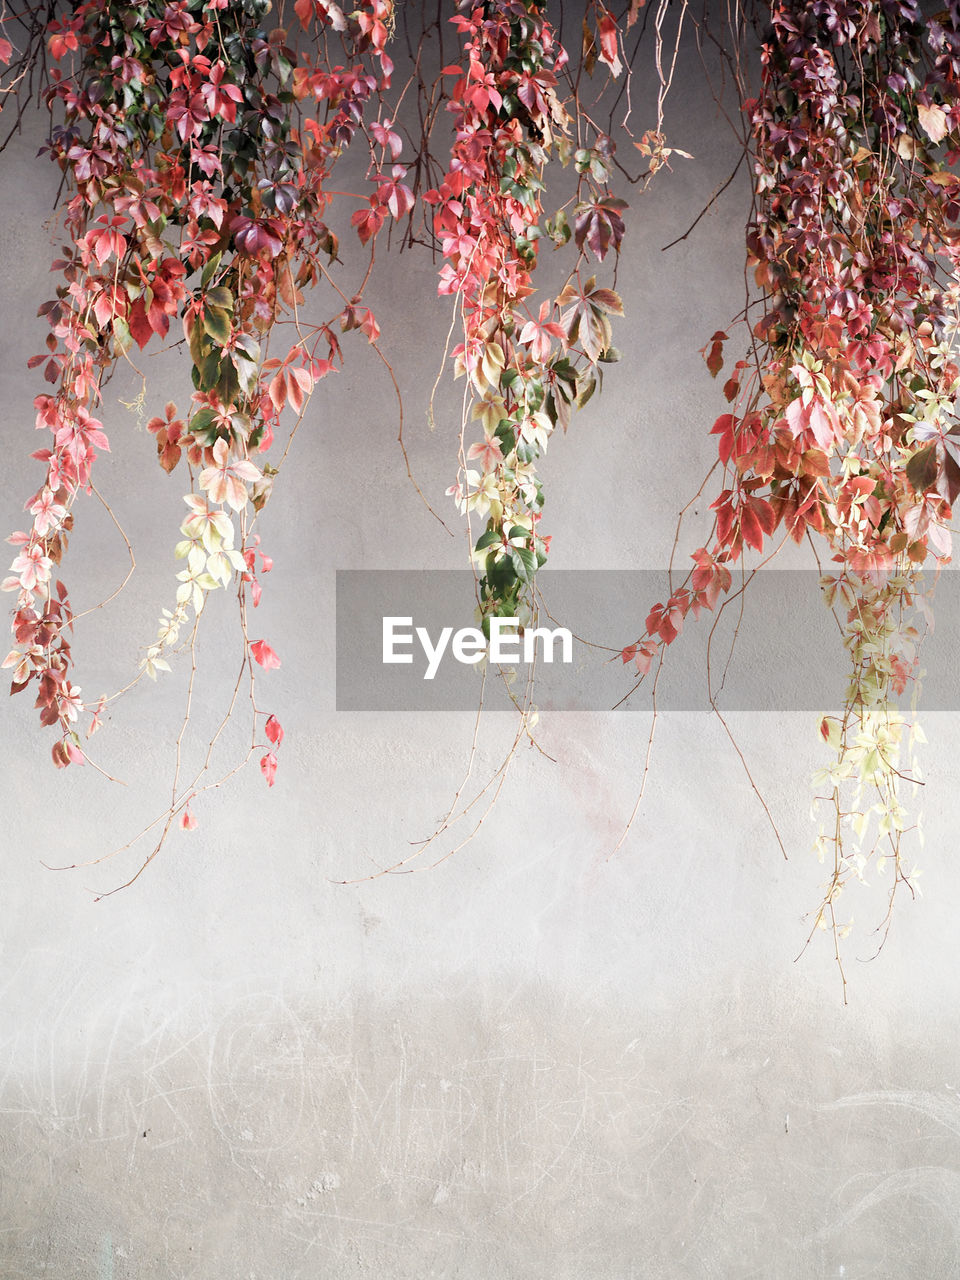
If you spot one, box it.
[623,0,960,962]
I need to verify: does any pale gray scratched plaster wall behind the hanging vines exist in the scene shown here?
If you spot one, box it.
[0,12,960,1280]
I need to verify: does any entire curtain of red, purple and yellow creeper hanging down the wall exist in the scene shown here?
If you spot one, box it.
[0,0,960,967]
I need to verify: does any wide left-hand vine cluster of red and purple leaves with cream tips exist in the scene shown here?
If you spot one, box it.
[0,0,399,798]
